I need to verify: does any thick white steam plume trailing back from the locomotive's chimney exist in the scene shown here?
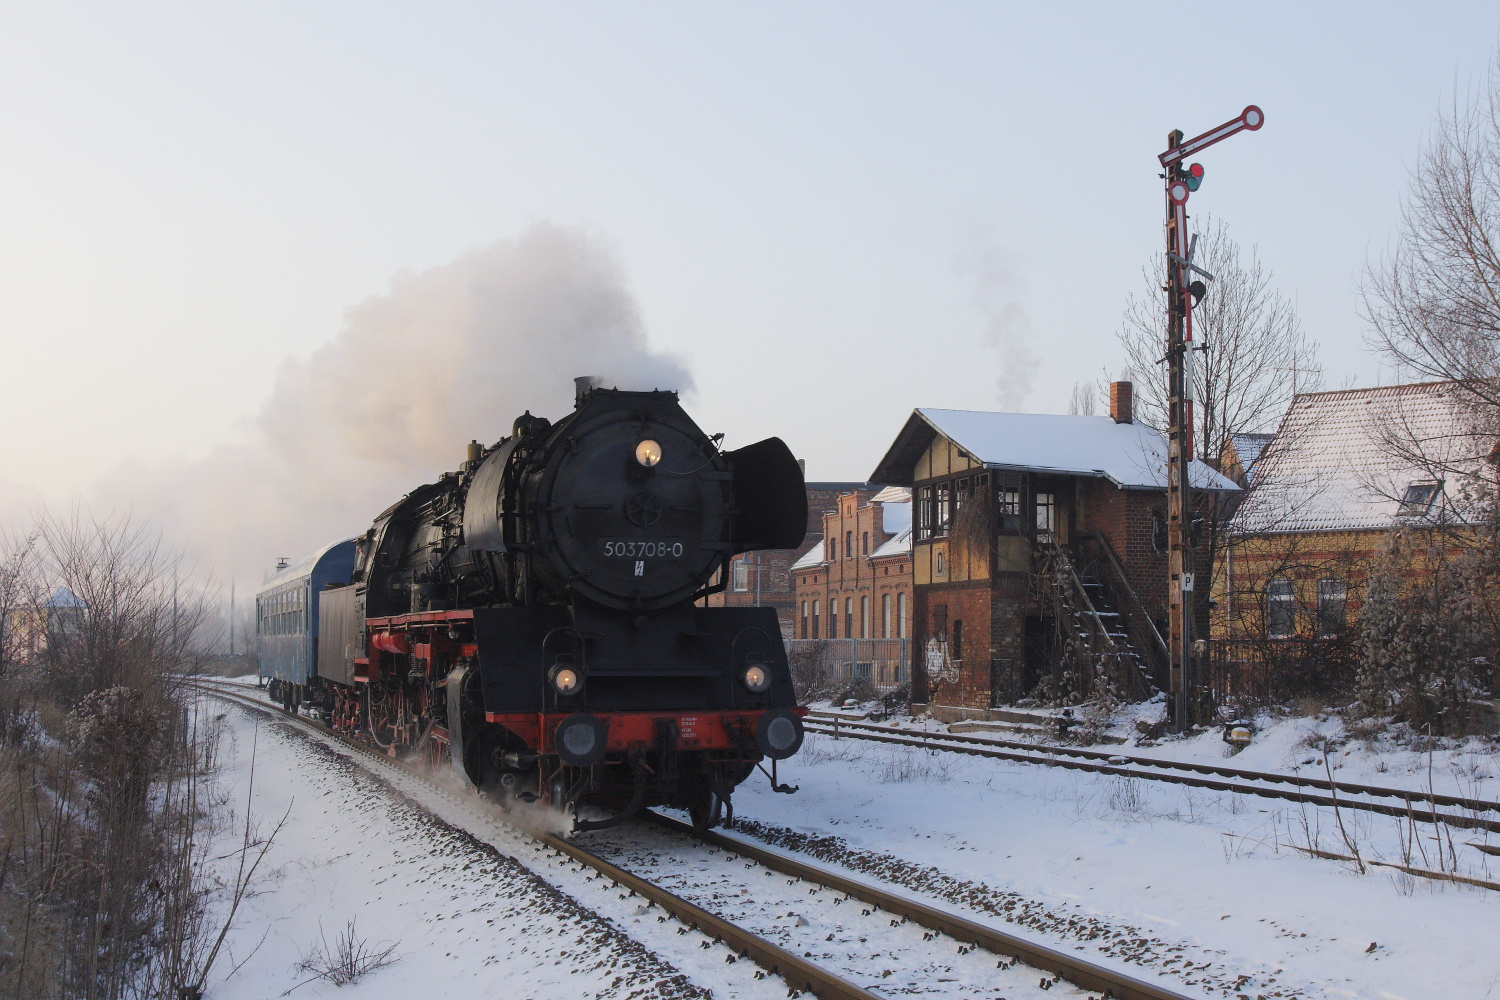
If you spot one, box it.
[92,225,692,587]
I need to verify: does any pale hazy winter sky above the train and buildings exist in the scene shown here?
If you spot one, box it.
[0,1,1500,513]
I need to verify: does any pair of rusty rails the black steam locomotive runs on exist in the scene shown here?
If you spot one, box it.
[189,679,1188,1000]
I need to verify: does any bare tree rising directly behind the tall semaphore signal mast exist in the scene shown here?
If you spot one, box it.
[1119,219,1323,460]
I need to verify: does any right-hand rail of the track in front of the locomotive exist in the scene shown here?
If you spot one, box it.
[647,813,1188,1000]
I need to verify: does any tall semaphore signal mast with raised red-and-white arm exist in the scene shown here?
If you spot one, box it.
[1157,105,1266,733]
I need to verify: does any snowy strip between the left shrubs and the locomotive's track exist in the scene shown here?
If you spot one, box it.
[199,708,786,1000]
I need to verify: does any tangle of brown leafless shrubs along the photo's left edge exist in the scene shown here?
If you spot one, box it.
[0,513,247,1000]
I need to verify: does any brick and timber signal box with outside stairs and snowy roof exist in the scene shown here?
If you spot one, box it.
[872,382,1239,720]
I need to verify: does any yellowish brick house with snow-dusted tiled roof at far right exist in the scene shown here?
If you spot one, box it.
[1212,382,1496,644]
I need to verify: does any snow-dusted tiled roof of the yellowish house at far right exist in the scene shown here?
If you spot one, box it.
[1232,382,1494,534]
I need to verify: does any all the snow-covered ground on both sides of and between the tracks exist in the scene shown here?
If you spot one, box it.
[210,683,1500,1000]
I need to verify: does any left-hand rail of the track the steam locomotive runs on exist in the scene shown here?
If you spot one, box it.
[188,678,876,1000]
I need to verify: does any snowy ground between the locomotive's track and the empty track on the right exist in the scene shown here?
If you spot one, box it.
[737,736,1500,1000]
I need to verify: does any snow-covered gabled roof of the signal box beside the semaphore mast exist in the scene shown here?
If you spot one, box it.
[870,409,1239,492]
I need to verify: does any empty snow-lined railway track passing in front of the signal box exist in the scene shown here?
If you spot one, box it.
[803,714,1500,834]
